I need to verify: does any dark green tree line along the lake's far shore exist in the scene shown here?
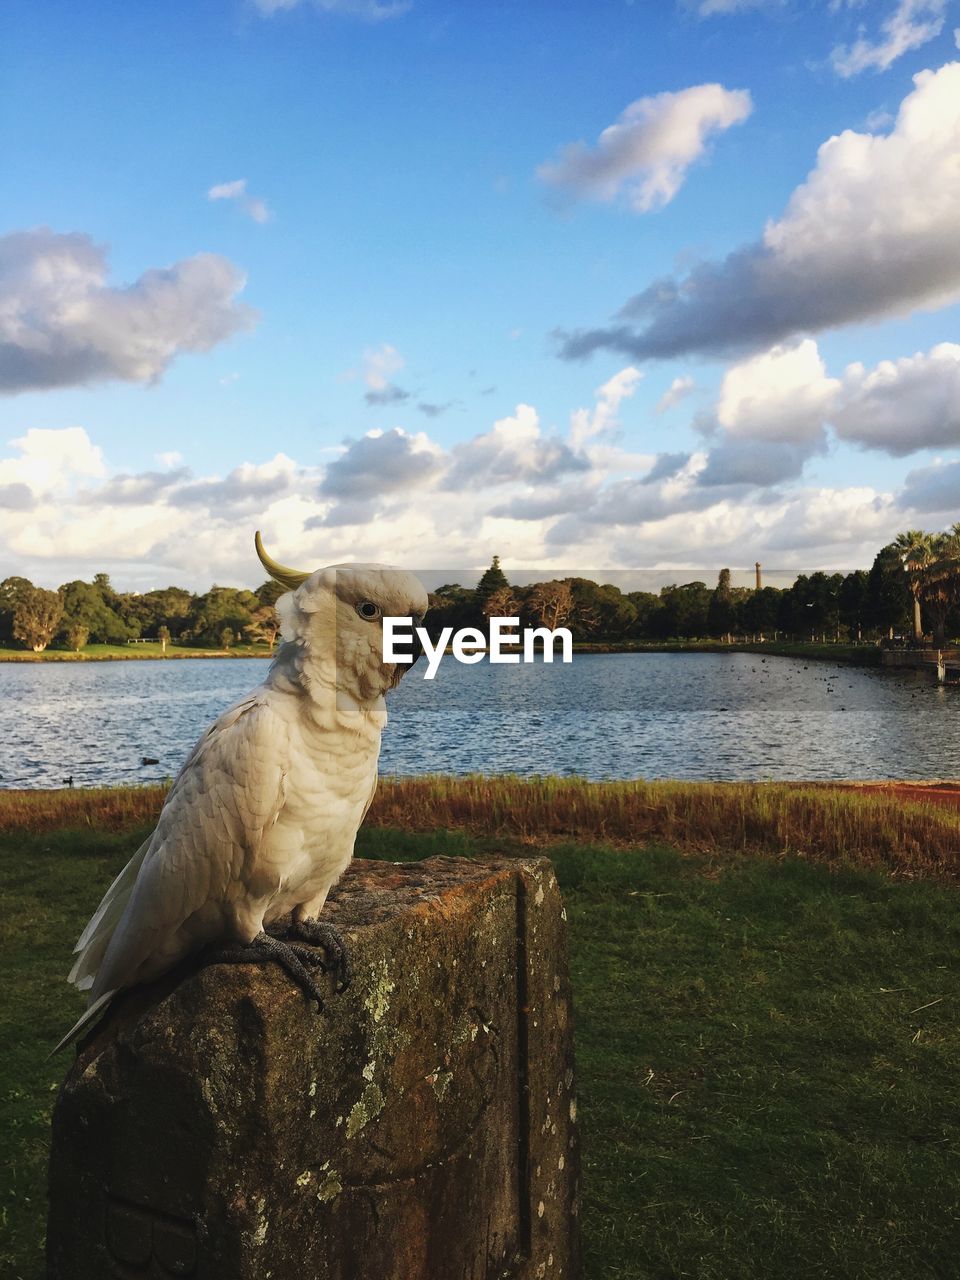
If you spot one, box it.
[0,525,960,652]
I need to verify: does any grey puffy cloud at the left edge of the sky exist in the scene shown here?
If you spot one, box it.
[0,227,256,393]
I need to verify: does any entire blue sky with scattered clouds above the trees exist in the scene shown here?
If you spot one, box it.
[0,0,960,588]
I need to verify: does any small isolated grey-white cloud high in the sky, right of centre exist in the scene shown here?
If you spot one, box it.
[536,84,753,214]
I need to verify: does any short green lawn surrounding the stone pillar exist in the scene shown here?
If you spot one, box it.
[0,788,960,1280]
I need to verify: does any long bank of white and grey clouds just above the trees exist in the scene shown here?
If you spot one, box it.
[0,348,960,589]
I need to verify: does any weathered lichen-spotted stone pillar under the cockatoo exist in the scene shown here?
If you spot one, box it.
[47,858,580,1280]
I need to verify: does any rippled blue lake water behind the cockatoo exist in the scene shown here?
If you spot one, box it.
[0,653,960,787]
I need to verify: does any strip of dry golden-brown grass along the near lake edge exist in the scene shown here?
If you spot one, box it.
[0,776,960,879]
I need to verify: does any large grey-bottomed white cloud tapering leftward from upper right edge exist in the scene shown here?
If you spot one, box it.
[561,63,960,360]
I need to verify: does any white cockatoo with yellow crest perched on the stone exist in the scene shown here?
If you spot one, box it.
[54,532,428,1052]
